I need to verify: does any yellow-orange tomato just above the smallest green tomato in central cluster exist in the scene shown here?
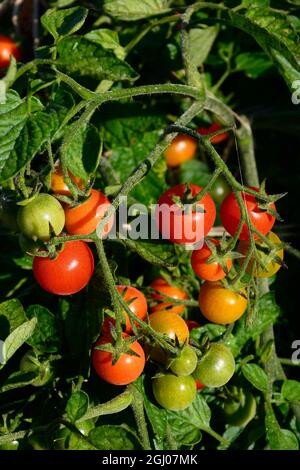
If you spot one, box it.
[149,310,189,343]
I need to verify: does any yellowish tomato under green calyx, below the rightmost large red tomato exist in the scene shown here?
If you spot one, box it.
[238,232,283,278]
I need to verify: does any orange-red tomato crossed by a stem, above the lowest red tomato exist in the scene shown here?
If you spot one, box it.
[102,286,148,334]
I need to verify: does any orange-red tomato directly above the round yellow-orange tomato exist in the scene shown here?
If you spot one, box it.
[191,239,232,281]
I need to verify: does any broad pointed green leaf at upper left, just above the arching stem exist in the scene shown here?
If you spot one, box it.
[57,37,138,81]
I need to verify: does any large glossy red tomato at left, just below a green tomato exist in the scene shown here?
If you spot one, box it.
[33,240,94,295]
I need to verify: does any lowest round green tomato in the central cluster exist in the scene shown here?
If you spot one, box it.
[152,374,196,411]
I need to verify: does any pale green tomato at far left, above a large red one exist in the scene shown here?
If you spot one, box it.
[18,194,65,241]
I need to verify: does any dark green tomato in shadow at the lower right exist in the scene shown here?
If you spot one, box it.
[224,391,256,426]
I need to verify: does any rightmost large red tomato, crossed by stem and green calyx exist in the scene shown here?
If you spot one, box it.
[220,187,275,240]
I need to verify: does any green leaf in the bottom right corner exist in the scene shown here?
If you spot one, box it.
[265,406,299,450]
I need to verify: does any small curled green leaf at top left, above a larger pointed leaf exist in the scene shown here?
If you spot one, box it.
[41,7,88,41]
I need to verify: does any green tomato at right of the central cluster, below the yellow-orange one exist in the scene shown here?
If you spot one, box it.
[193,343,235,387]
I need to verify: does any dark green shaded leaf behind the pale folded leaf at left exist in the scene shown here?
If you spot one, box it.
[26,305,61,353]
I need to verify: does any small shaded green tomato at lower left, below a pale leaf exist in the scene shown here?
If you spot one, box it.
[20,350,54,387]
